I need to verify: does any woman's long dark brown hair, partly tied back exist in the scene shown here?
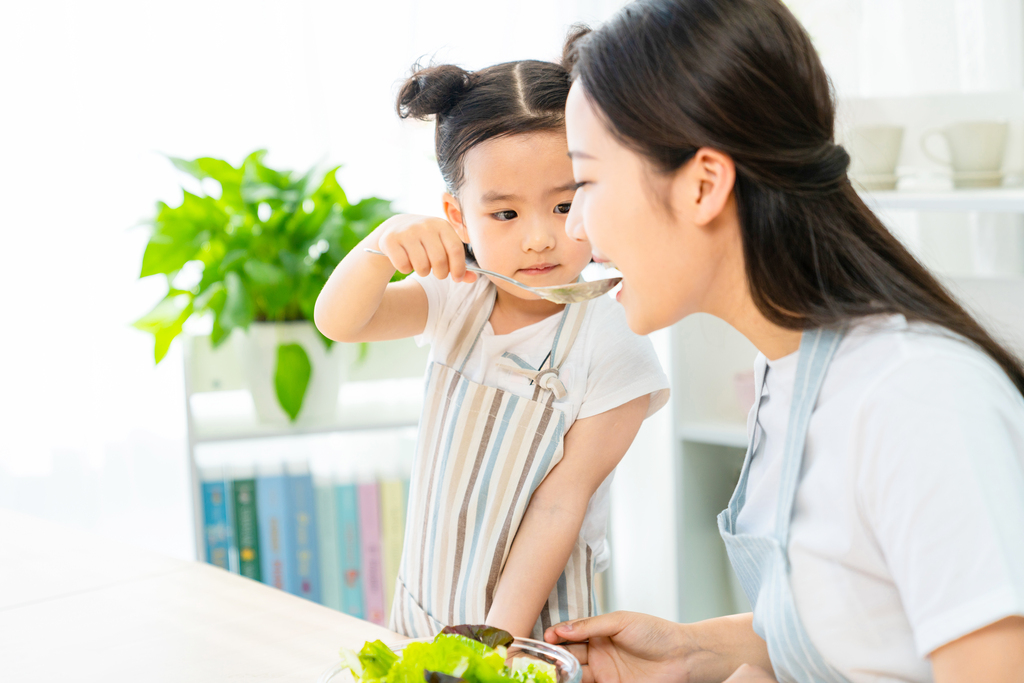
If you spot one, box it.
[563,0,1024,394]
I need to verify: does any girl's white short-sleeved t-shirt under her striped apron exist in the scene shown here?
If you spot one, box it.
[414,276,669,571]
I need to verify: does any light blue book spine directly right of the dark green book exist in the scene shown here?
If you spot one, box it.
[256,475,295,592]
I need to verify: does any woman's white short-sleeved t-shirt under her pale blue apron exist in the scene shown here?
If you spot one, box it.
[736,315,1024,683]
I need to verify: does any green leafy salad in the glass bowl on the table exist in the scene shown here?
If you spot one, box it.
[341,626,558,683]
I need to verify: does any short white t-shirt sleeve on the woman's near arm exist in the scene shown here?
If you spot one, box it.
[854,354,1024,656]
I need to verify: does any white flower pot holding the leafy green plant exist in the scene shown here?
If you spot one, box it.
[237,321,351,424]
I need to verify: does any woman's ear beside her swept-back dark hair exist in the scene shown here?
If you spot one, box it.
[672,147,736,225]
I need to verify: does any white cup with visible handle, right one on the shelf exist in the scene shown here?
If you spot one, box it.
[921,121,1010,187]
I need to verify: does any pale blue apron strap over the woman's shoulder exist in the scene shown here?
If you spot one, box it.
[775,328,846,549]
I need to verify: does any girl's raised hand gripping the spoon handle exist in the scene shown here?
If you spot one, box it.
[375,214,476,283]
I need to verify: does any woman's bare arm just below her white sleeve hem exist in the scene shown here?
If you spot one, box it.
[929,616,1024,683]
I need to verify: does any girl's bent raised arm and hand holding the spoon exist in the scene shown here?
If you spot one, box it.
[313,215,475,342]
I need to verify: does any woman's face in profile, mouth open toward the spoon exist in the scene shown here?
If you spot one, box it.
[565,82,738,334]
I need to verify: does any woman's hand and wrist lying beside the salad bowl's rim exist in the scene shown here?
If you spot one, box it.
[544,612,773,683]
